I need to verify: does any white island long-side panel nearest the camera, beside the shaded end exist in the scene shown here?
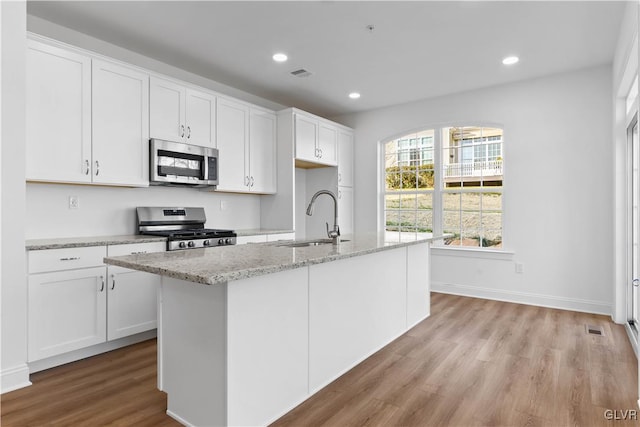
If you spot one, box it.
[227,267,309,426]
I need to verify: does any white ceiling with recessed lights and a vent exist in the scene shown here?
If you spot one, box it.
[27,1,625,117]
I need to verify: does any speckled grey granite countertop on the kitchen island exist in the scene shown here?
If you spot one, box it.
[104,233,441,285]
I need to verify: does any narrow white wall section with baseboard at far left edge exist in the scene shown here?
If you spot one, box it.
[0,1,30,392]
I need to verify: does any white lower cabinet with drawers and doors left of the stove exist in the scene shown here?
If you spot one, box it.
[28,242,165,362]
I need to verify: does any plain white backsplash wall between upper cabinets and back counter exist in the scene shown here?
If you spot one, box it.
[25,183,260,239]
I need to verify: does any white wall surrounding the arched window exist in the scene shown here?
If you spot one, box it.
[338,63,613,313]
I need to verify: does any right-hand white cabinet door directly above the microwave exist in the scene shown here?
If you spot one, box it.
[185,89,216,148]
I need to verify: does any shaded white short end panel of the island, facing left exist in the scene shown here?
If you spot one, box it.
[160,277,227,426]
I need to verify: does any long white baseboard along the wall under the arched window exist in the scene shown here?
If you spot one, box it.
[431,282,612,316]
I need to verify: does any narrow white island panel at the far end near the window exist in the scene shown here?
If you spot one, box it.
[407,243,431,329]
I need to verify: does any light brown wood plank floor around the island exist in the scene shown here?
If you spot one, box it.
[0,293,640,427]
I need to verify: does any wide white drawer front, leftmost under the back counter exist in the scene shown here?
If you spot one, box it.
[28,246,107,273]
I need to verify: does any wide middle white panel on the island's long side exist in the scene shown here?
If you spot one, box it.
[309,247,407,393]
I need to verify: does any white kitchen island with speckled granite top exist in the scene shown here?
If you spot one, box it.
[105,234,434,426]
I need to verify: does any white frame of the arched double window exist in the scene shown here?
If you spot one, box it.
[378,120,512,251]
